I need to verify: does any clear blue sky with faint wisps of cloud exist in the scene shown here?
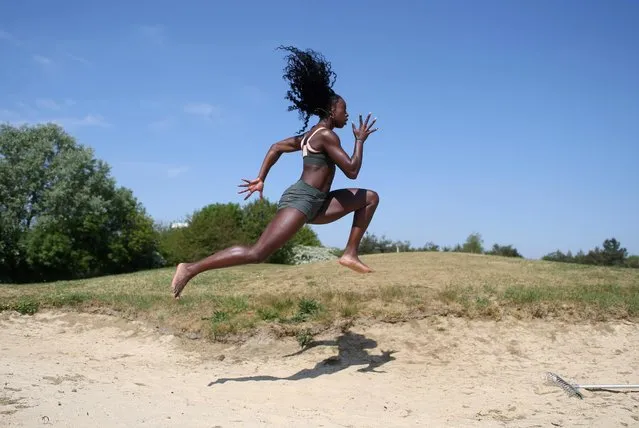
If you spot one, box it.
[0,0,639,258]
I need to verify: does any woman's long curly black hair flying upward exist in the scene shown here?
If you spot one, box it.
[278,46,339,133]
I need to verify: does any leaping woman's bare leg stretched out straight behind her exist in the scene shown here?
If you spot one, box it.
[171,208,306,299]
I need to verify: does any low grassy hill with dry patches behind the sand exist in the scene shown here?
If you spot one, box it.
[0,252,639,340]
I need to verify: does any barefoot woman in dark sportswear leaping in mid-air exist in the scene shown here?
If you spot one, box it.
[171,47,379,299]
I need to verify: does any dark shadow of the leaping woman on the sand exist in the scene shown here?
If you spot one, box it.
[208,332,395,386]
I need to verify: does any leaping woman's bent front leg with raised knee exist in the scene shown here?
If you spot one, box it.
[309,188,379,273]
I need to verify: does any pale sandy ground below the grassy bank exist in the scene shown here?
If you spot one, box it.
[0,312,639,428]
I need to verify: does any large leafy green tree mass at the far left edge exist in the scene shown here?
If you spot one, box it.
[0,124,162,282]
